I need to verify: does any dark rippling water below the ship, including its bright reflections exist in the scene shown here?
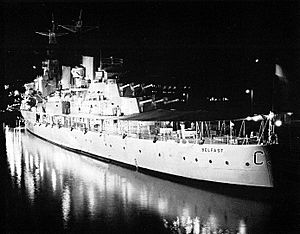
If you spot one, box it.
[1,128,299,234]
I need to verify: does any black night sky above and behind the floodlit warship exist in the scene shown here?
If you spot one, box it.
[1,1,300,109]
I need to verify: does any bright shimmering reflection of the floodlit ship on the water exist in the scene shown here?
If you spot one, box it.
[6,130,271,234]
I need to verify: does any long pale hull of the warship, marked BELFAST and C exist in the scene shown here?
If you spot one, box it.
[22,111,273,187]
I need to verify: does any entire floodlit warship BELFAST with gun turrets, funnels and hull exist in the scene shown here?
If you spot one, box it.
[21,13,279,188]
